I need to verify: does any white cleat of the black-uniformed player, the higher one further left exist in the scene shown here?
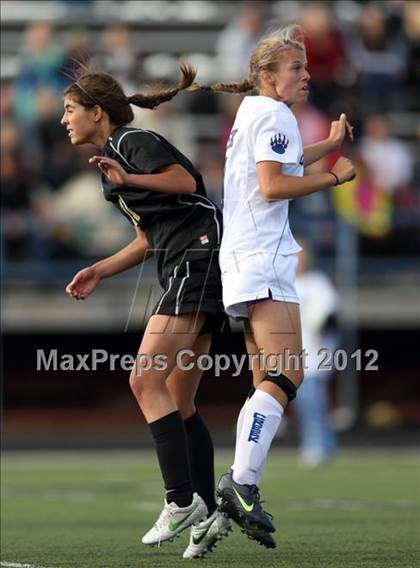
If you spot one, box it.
[141,493,207,546]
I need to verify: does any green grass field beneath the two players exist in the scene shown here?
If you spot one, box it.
[0,450,420,568]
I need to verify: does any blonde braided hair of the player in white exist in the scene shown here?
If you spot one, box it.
[188,24,305,93]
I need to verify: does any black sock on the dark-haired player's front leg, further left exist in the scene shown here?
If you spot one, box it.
[149,410,193,507]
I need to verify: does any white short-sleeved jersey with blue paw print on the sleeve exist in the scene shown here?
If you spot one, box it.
[220,96,303,270]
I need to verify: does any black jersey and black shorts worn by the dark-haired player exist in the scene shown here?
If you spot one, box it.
[102,127,222,326]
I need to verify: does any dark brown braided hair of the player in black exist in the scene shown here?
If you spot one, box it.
[64,62,197,126]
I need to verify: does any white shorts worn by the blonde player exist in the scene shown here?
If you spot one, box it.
[221,253,299,318]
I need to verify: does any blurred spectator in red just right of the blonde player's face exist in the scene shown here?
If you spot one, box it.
[300,2,348,112]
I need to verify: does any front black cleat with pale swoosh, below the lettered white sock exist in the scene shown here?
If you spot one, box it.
[217,472,276,536]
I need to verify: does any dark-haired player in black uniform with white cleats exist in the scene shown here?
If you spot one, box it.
[61,64,231,558]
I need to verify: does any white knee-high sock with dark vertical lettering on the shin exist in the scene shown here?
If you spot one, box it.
[232,389,283,485]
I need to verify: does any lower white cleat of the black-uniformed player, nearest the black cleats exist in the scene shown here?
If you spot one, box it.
[182,509,232,559]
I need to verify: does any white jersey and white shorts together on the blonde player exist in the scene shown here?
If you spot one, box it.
[219,96,303,317]
